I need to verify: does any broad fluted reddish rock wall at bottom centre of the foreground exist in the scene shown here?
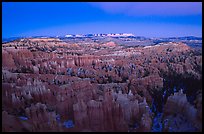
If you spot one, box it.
[73,90,128,131]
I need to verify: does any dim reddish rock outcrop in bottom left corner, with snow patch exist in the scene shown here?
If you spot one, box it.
[2,103,62,132]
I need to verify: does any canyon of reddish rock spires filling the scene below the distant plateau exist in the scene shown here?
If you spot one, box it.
[2,38,202,132]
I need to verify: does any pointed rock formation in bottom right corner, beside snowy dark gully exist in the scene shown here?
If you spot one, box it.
[164,90,202,131]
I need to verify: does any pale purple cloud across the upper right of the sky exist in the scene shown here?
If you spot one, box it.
[90,2,202,16]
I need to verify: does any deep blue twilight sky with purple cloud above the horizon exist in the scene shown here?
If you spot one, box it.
[2,2,202,38]
